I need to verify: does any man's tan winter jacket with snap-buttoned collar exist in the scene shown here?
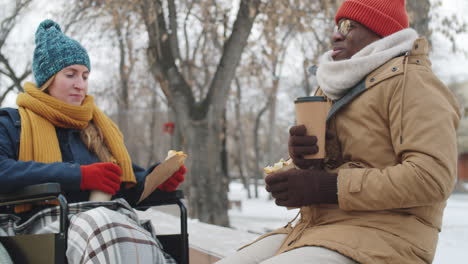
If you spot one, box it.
[250,38,460,264]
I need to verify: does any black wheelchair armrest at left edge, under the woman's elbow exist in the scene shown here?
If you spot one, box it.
[0,183,61,205]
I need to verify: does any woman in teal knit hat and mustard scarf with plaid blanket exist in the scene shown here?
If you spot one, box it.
[0,20,186,263]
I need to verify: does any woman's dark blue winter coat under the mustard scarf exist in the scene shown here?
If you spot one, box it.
[0,108,154,203]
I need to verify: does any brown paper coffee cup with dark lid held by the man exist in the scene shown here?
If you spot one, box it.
[294,96,329,159]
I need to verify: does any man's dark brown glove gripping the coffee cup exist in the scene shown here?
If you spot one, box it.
[288,125,323,169]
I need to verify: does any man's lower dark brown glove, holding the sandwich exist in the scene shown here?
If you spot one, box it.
[265,169,338,207]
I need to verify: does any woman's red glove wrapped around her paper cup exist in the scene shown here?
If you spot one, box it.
[80,162,122,195]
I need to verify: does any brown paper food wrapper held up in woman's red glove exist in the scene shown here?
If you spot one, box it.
[138,150,187,203]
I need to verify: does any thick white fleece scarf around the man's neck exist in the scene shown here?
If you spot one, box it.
[317,28,418,100]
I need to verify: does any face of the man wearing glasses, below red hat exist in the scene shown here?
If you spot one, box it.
[332,18,381,61]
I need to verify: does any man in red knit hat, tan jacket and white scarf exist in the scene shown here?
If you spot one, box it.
[220,0,460,264]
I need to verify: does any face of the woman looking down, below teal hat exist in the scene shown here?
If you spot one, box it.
[47,64,89,105]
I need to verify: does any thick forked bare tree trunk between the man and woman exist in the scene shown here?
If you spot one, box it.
[141,0,260,226]
